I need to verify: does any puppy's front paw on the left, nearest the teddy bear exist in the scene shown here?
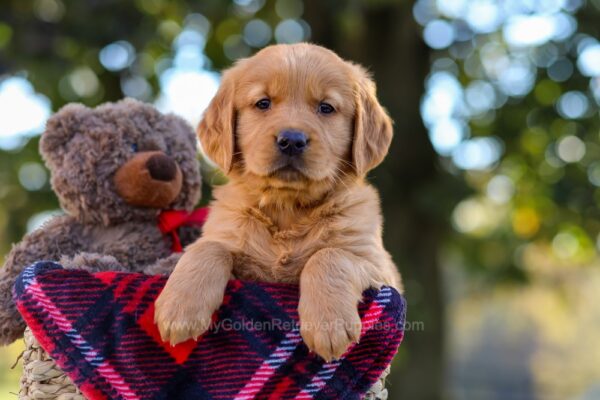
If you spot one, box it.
[154,286,223,345]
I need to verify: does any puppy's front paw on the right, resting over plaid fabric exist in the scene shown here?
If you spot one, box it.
[298,298,362,362]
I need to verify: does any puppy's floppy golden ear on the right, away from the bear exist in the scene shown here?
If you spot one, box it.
[352,65,393,176]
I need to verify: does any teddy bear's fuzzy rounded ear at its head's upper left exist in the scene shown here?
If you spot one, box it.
[40,104,92,167]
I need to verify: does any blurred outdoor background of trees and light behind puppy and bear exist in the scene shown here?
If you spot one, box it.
[0,0,600,400]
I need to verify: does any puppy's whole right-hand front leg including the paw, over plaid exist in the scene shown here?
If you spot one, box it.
[298,248,383,361]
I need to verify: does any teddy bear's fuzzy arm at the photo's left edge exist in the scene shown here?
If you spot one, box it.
[0,216,81,346]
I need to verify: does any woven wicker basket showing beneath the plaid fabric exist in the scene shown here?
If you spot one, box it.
[19,328,390,400]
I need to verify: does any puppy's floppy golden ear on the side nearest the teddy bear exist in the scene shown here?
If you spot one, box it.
[198,70,237,173]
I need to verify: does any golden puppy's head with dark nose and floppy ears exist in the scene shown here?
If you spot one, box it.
[198,44,392,203]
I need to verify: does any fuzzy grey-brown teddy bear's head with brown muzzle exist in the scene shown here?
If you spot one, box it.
[40,99,201,225]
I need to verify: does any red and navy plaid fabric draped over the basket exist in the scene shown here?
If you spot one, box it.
[14,262,406,399]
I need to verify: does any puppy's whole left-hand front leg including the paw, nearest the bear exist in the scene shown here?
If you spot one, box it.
[154,239,233,345]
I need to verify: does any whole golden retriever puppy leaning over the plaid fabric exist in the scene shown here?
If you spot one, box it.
[155,44,401,360]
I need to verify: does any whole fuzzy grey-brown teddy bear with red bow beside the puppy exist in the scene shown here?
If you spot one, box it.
[0,99,201,345]
